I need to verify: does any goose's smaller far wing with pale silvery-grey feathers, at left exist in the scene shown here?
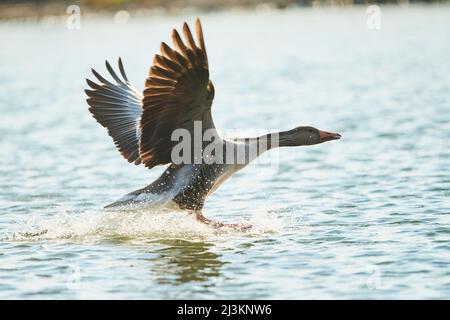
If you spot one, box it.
[85,58,142,164]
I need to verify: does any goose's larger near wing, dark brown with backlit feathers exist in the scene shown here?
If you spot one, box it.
[139,19,214,168]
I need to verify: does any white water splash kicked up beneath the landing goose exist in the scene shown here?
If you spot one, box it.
[7,208,284,241]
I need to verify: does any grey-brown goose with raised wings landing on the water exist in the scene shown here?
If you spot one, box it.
[85,19,341,228]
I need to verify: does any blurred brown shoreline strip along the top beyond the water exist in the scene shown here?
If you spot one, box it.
[0,0,450,20]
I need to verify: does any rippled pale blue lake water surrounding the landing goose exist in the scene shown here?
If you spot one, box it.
[0,6,450,299]
